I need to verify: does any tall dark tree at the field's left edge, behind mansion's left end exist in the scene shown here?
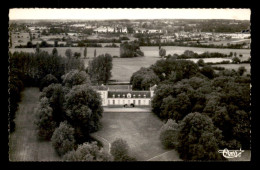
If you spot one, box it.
[88,54,113,84]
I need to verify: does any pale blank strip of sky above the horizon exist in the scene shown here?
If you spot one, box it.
[9,8,251,20]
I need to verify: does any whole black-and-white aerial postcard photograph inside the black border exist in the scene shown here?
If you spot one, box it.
[8,8,252,162]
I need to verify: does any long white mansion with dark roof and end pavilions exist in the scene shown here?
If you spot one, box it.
[96,85,156,106]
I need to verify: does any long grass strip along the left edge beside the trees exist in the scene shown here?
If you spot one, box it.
[9,88,60,162]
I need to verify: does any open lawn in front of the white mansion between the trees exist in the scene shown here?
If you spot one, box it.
[92,112,179,161]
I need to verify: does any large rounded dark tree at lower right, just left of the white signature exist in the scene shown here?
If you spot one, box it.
[177,112,223,160]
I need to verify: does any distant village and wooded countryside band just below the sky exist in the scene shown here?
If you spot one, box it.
[11,20,251,48]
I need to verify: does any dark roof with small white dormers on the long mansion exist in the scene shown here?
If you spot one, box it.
[108,91,151,98]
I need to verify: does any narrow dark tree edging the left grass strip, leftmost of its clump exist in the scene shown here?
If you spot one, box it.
[35,97,56,140]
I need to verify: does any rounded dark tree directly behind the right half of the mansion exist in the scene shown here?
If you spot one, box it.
[130,67,160,90]
